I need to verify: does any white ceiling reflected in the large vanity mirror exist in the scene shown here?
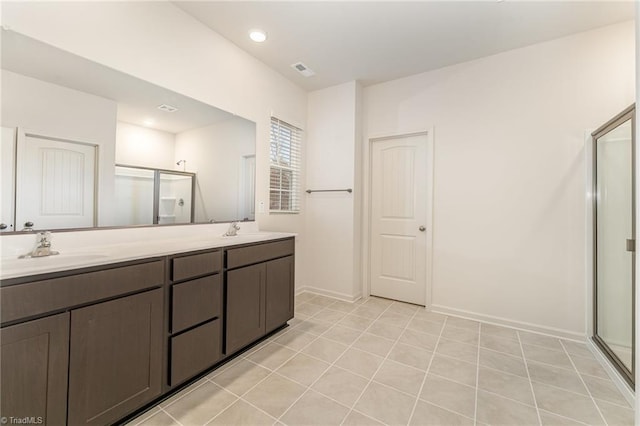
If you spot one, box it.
[0,30,234,133]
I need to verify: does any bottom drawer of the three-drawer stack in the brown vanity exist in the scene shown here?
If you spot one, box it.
[169,319,222,386]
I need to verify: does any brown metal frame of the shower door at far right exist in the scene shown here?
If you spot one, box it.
[591,104,636,389]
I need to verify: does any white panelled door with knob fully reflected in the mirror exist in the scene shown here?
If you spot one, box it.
[16,132,96,230]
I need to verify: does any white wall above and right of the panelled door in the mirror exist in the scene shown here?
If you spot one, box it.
[1,70,117,226]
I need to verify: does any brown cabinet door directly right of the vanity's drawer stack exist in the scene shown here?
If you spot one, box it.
[225,263,266,354]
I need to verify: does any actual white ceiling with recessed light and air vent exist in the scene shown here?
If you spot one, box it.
[173,0,634,91]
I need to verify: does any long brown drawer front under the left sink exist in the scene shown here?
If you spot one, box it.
[0,260,165,323]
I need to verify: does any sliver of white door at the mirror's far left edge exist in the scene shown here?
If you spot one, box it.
[0,127,16,232]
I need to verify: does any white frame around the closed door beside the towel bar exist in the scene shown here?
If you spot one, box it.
[361,126,435,309]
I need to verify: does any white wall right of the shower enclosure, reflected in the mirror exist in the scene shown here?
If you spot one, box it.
[175,118,256,222]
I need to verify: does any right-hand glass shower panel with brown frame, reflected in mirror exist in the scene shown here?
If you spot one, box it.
[158,172,193,224]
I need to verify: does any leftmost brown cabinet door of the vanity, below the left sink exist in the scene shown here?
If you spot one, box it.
[0,313,69,425]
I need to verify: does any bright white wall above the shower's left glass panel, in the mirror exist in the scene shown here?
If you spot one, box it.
[116,121,176,170]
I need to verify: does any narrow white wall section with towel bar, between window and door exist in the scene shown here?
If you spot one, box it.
[303,82,362,300]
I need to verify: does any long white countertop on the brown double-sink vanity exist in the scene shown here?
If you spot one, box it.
[0,231,296,280]
